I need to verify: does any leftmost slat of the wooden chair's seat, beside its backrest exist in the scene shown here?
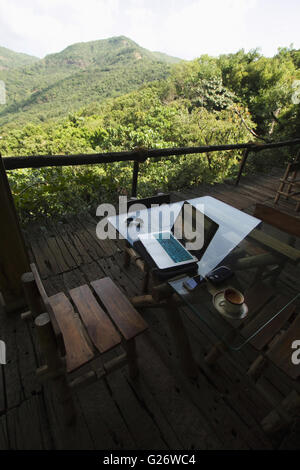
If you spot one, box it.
[48,292,94,372]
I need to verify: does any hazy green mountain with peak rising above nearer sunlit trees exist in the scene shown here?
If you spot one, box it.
[0,36,180,125]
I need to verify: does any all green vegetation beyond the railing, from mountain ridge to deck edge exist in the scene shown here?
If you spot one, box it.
[0,37,300,222]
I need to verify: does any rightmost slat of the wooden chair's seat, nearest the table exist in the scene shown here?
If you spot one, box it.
[91,277,148,340]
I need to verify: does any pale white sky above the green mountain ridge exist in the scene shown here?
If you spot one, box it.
[0,0,300,60]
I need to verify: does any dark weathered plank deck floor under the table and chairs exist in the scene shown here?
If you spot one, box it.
[0,174,300,450]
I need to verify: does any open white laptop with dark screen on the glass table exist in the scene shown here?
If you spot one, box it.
[134,202,219,272]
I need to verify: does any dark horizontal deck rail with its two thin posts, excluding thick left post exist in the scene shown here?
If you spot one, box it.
[3,138,300,196]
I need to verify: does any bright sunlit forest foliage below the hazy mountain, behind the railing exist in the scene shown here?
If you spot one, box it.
[0,75,253,222]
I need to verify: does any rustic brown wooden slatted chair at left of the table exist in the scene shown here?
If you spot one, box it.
[22,264,147,424]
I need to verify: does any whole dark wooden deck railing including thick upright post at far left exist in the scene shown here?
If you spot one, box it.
[0,139,300,312]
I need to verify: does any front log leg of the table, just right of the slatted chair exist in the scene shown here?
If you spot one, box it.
[166,294,198,378]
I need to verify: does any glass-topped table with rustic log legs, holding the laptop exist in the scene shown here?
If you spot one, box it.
[110,197,300,377]
